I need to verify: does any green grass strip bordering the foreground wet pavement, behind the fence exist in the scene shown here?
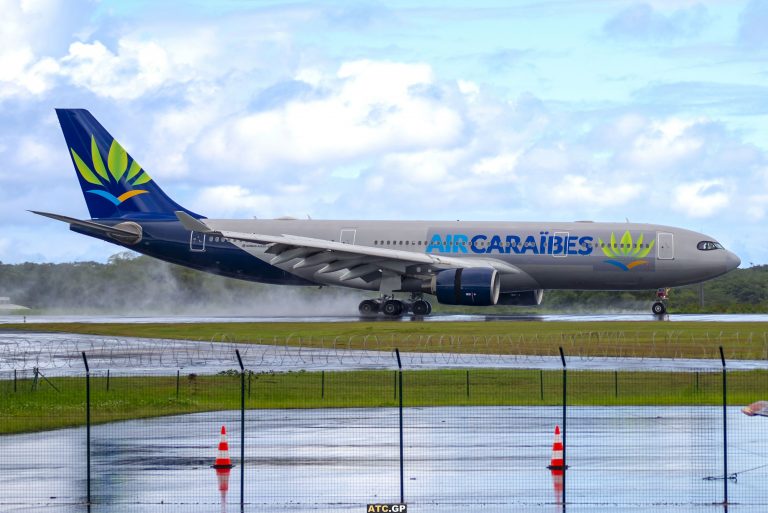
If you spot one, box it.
[0,370,768,434]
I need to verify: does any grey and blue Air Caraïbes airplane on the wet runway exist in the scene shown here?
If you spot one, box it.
[32,109,741,318]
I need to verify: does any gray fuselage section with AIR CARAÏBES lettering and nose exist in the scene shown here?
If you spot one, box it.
[201,219,740,292]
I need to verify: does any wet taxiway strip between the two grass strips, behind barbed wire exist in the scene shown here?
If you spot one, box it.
[0,332,766,376]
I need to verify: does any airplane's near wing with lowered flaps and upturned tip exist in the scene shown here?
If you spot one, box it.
[176,212,521,281]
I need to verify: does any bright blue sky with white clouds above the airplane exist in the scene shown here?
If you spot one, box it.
[0,0,768,266]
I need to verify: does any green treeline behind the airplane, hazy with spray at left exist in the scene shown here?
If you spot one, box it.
[0,253,768,315]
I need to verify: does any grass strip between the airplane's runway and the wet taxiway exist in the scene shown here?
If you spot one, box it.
[3,321,768,359]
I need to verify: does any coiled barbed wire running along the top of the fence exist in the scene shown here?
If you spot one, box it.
[0,330,768,374]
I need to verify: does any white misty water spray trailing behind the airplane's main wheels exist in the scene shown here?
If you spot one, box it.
[0,252,365,317]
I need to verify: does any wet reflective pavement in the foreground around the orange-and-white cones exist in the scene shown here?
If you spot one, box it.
[0,407,768,513]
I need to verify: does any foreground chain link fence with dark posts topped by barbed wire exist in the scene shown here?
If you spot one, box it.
[0,339,768,512]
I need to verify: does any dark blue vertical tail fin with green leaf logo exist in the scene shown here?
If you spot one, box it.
[56,109,202,219]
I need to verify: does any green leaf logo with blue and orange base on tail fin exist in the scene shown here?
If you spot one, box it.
[69,134,152,206]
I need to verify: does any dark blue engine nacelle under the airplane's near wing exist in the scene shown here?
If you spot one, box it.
[432,267,501,306]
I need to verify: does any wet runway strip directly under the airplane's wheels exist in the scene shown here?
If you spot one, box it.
[0,312,768,325]
